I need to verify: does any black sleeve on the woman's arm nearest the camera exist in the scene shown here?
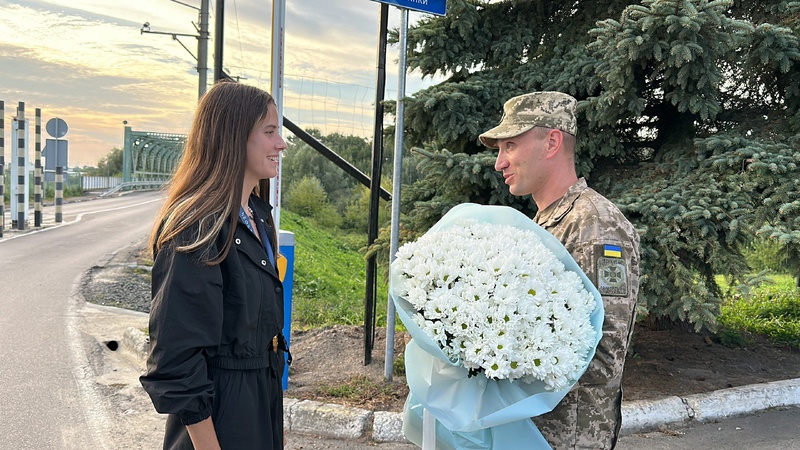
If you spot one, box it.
[140,247,223,425]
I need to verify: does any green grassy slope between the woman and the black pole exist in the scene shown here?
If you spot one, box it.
[281,209,388,329]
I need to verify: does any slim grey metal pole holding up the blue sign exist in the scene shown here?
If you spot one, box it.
[383,8,408,381]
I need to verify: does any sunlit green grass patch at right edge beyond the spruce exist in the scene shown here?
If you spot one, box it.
[717,275,800,348]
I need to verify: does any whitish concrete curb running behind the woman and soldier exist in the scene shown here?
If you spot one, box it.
[121,328,800,442]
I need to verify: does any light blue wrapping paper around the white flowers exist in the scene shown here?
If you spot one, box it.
[390,203,603,450]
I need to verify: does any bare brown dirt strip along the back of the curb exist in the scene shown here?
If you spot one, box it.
[286,323,800,411]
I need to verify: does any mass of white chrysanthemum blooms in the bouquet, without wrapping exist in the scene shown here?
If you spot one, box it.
[393,221,595,390]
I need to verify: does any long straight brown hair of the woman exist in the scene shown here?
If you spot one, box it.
[150,81,275,265]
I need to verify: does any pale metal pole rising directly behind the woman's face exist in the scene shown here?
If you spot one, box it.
[269,0,286,231]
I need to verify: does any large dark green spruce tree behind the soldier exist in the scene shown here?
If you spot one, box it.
[394,0,800,328]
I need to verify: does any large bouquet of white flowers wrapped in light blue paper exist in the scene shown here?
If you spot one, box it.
[390,204,603,449]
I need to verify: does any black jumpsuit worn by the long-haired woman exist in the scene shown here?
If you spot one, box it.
[140,196,285,450]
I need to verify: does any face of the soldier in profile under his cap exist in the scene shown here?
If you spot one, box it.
[494,128,546,197]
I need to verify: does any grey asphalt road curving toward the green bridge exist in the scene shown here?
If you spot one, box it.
[0,192,160,450]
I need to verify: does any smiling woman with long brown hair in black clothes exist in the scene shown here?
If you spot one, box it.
[141,82,286,450]
